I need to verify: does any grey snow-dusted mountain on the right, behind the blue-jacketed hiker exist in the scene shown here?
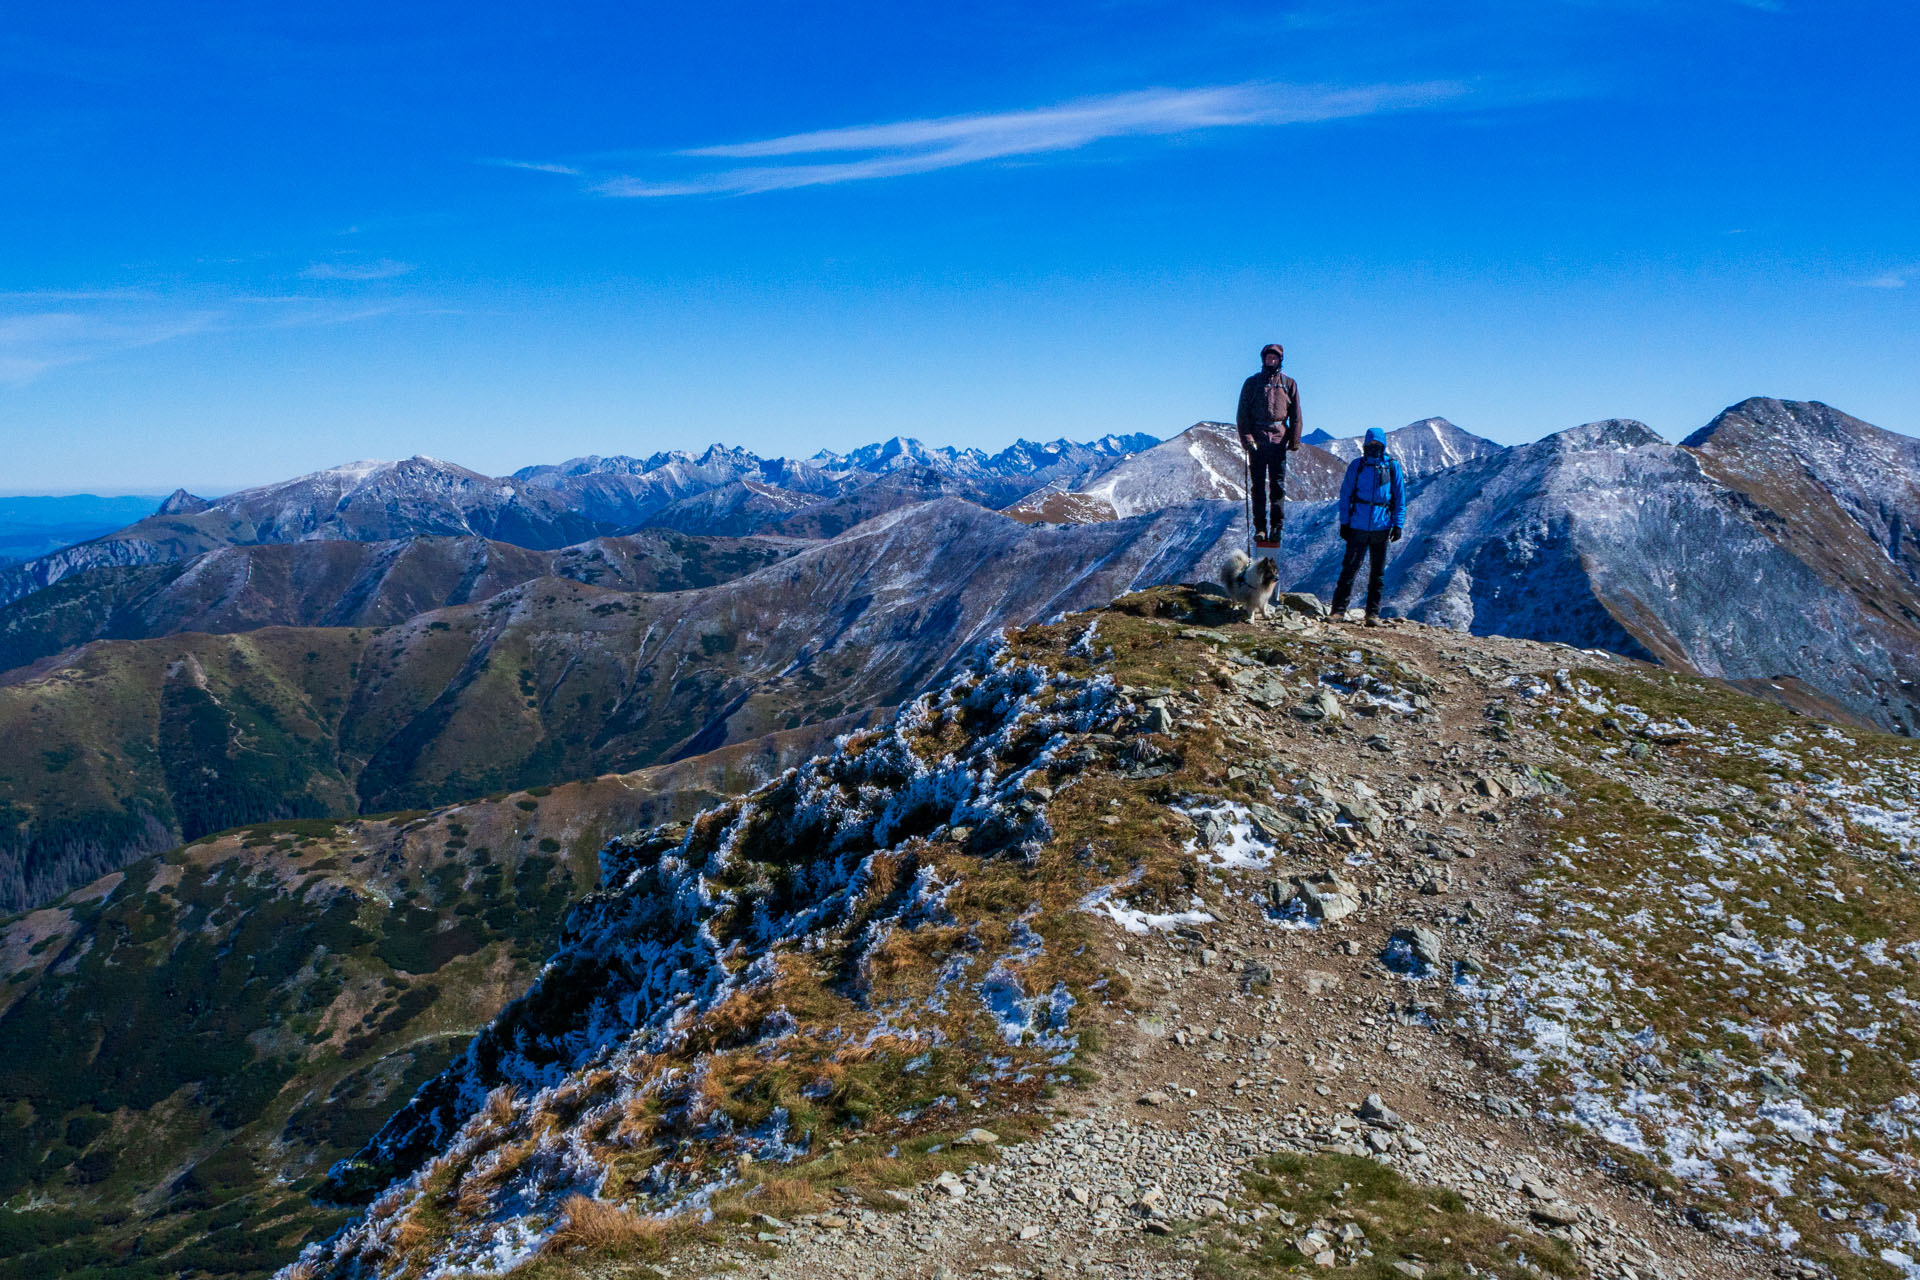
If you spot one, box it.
[1286,399,1920,733]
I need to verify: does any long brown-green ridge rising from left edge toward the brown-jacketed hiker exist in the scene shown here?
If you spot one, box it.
[0,499,1238,906]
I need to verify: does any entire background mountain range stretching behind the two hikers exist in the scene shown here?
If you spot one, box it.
[0,399,1920,906]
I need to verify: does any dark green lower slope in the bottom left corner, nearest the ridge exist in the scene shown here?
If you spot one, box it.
[0,731,856,1280]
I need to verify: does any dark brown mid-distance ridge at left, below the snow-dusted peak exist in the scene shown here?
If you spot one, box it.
[0,530,801,679]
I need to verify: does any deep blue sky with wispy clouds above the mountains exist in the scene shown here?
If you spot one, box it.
[0,0,1920,491]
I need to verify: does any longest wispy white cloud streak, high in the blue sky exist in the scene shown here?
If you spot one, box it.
[576,81,1467,198]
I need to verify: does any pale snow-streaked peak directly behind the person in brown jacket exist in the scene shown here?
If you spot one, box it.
[1006,422,1346,524]
